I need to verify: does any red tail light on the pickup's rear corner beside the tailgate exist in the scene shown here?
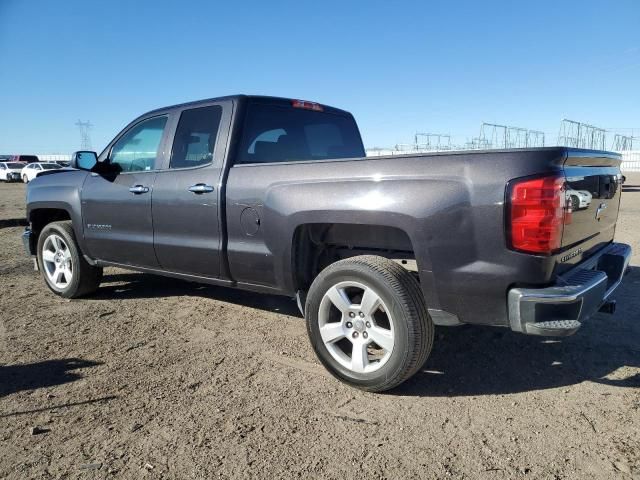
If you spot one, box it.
[507,175,566,254]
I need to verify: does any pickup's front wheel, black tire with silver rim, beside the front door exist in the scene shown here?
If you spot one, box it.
[37,221,102,298]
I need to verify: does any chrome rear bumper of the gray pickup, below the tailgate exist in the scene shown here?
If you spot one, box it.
[508,243,631,336]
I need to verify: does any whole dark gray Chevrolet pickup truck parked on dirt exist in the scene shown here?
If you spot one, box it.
[24,96,631,391]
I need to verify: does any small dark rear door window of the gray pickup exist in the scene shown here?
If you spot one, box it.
[169,105,222,168]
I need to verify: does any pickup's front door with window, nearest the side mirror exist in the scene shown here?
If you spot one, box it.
[82,115,168,268]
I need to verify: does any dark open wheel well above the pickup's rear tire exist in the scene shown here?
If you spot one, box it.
[292,223,418,291]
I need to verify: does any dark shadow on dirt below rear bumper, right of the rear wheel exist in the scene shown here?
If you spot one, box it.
[394,267,640,396]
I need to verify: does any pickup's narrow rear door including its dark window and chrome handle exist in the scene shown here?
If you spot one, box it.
[152,101,232,278]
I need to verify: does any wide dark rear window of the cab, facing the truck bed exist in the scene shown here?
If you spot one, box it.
[236,104,365,163]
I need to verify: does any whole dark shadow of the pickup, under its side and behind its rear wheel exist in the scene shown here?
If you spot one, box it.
[92,267,640,397]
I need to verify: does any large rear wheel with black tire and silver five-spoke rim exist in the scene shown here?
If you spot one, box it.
[305,255,434,392]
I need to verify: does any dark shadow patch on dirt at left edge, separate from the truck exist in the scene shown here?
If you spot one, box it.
[0,358,101,398]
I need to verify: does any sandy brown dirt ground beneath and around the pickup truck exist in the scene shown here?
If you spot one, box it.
[0,175,640,479]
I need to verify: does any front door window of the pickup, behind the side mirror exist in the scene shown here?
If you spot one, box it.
[109,117,167,172]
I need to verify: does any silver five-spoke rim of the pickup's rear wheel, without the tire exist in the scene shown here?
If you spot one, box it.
[318,281,394,373]
